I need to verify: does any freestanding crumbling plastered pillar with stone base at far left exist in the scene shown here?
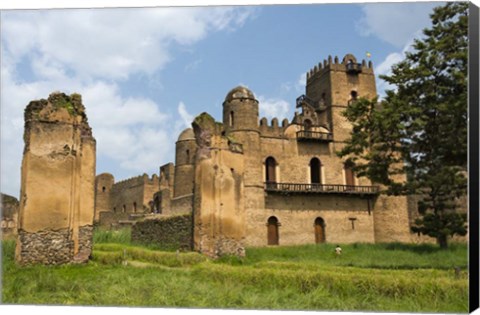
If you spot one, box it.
[15,93,96,264]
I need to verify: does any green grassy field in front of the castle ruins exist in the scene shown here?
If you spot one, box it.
[2,230,468,313]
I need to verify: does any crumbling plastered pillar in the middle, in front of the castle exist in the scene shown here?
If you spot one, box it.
[192,113,245,258]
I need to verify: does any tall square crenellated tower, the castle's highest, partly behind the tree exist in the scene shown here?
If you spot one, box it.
[306,54,377,142]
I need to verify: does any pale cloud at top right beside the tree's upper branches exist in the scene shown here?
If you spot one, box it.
[356,2,439,47]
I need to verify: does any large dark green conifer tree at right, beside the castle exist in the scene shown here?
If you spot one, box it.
[338,2,468,248]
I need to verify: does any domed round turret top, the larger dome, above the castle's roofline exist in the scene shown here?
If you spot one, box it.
[223,86,258,132]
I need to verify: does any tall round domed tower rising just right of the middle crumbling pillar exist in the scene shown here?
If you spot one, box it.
[223,86,265,244]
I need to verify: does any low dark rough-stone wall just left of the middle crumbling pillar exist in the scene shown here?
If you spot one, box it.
[132,213,193,250]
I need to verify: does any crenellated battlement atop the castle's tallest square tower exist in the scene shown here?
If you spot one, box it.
[307,54,373,83]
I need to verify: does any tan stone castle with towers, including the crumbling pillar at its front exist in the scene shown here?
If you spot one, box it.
[95,54,416,253]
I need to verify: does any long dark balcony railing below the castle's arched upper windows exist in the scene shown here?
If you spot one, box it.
[265,182,378,195]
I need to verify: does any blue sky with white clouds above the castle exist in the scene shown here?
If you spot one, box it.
[0,2,441,197]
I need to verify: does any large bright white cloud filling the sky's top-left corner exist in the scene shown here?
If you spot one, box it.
[2,7,251,79]
